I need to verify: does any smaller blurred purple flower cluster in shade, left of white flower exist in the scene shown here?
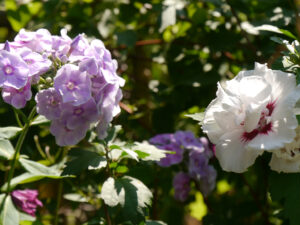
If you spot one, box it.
[149,131,217,201]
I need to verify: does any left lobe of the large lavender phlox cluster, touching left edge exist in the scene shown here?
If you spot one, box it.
[0,30,52,109]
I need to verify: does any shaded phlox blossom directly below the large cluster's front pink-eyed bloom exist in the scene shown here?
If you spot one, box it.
[61,98,98,130]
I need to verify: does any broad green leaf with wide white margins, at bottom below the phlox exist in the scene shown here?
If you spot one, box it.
[101,176,152,224]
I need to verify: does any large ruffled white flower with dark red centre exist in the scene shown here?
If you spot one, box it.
[202,63,300,173]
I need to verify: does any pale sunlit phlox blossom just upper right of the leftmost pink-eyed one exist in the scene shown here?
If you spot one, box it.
[19,48,52,76]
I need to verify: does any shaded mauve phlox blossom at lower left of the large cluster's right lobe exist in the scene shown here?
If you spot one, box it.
[35,88,62,120]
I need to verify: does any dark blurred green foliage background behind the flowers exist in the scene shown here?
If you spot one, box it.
[0,0,300,225]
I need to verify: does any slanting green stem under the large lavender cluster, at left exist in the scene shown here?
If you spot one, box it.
[6,107,36,193]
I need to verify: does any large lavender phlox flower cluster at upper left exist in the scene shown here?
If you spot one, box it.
[0,29,125,146]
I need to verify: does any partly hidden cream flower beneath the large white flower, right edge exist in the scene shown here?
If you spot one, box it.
[270,126,300,173]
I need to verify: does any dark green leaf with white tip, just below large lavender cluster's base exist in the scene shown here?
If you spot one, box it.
[62,149,107,175]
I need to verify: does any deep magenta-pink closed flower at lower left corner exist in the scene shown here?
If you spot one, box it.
[11,189,43,217]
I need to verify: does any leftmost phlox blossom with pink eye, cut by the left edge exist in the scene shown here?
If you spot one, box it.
[0,50,29,89]
